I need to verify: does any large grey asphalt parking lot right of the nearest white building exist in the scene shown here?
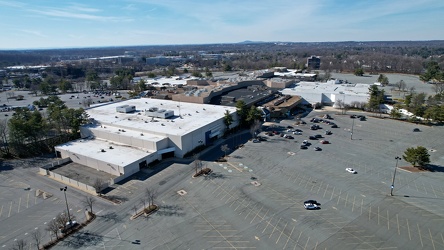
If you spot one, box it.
[3,110,444,249]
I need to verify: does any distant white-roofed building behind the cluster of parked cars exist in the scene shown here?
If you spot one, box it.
[281,80,370,107]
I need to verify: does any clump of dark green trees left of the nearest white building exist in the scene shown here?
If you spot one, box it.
[0,96,89,157]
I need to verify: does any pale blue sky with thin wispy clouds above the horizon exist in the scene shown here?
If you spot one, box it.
[0,0,444,49]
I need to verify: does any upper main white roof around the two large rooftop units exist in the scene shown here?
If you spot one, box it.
[86,98,236,137]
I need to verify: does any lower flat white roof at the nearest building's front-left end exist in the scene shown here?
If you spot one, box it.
[55,139,156,167]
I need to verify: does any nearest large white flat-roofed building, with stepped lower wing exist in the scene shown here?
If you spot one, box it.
[55,99,238,182]
